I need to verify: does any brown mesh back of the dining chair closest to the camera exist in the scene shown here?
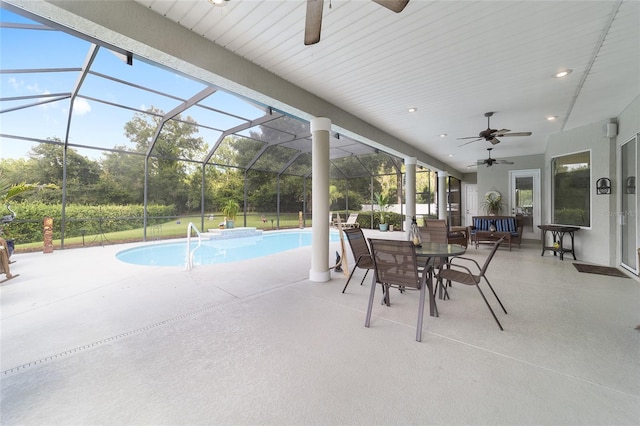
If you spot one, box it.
[369,239,420,289]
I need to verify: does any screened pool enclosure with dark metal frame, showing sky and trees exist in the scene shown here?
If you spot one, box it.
[0,4,460,248]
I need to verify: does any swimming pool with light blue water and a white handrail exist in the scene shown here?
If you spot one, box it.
[116,231,340,266]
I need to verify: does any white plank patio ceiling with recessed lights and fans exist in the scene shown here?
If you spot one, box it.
[137,0,640,172]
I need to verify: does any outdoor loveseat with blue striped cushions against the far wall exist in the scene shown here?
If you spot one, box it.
[469,215,523,251]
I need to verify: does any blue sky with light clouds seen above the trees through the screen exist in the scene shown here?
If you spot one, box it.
[0,8,264,163]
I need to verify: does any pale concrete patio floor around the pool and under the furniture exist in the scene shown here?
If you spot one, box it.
[0,231,640,425]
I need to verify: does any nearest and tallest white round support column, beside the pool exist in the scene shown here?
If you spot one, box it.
[309,118,331,282]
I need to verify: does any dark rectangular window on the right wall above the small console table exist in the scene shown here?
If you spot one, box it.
[551,151,591,227]
